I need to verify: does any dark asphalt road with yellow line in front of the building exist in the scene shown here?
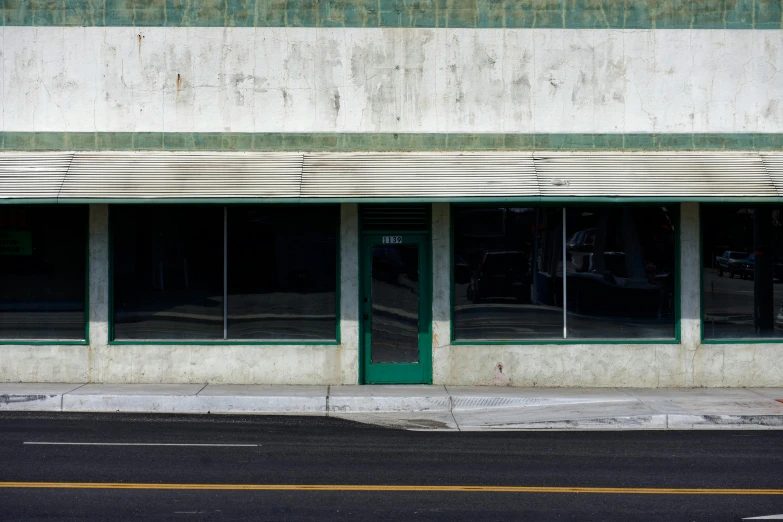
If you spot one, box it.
[0,413,783,522]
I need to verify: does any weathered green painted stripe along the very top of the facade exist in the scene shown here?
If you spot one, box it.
[2,0,783,29]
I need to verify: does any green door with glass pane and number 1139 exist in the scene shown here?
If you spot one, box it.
[360,232,432,384]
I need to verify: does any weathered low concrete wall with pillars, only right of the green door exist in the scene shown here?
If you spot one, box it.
[433,203,783,387]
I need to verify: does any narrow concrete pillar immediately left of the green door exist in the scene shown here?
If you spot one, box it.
[338,203,359,384]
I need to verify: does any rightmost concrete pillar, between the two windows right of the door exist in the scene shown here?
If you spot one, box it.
[680,203,701,386]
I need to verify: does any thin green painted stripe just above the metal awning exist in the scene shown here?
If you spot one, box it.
[0,132,783,152]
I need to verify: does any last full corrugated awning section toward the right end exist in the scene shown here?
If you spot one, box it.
[534,152,778,198]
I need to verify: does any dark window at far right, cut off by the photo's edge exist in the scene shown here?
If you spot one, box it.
[701,206,783,339]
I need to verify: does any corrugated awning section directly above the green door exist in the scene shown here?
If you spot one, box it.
[302,153,539,199]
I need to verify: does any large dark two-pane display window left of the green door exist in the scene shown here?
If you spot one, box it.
[111,206,339,342]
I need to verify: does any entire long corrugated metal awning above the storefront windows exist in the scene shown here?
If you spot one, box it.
[0,152,783,203]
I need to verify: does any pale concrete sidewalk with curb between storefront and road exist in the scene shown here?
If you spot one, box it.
[0,383,783,431]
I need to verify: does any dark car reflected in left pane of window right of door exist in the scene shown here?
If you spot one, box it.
[467,250,530,303]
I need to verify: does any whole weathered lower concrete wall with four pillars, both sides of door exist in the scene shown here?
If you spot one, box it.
[0,203,783,387]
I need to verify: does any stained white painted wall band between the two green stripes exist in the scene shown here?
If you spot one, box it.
[0,27,783,133]
